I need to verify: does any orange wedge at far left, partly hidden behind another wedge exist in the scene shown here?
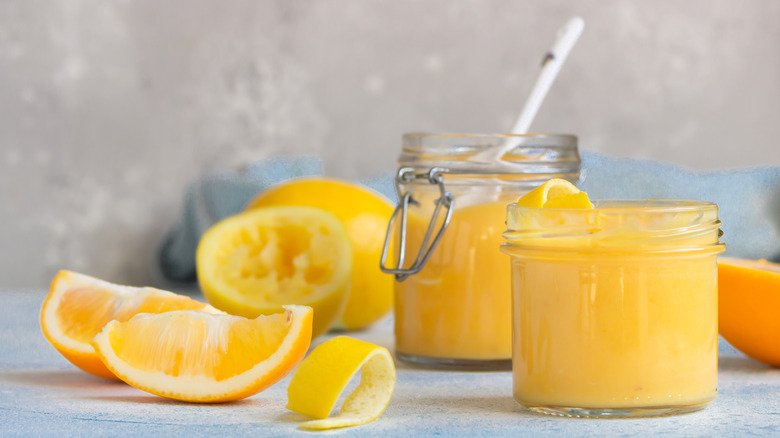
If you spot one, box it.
[41,270,219,379]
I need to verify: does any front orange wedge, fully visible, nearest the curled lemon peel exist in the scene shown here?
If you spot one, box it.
[92,306,312,403]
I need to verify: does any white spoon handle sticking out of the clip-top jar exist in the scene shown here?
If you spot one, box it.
[473,17,585,163]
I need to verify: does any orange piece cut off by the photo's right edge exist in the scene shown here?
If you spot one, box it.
[718,257,780,367]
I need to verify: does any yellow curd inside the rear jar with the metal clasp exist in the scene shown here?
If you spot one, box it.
[395,201,512,361]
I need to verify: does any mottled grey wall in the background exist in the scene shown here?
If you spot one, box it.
[0,0,780,287]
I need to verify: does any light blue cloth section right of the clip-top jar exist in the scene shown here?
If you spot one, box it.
[580,153,780,261]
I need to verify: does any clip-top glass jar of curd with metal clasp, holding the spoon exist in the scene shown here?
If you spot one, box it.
[381,134,580,369]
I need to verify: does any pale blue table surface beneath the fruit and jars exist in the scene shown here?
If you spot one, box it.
[0,289,780,437]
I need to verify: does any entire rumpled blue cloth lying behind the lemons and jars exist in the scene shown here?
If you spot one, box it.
[153,152,780,290]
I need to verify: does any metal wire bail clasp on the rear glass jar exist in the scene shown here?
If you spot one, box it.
[379,167,455,281]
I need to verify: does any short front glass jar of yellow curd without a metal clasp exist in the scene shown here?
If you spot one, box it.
[502,200,724,417]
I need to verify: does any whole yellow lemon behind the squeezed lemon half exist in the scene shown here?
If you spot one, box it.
[247,177,394,330]
